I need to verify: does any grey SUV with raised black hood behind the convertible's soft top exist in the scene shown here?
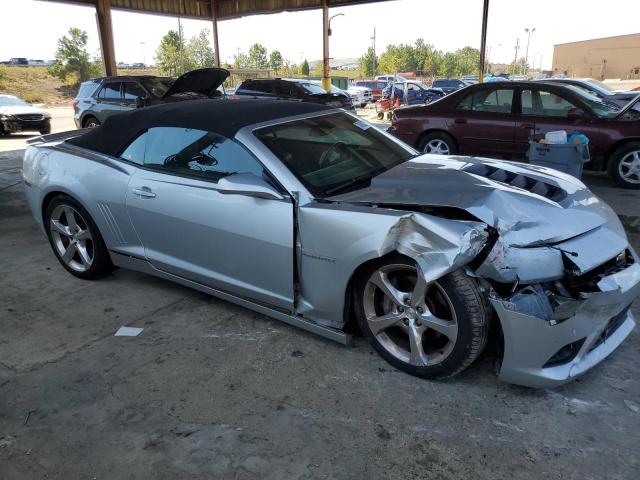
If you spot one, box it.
[72,68,229,128]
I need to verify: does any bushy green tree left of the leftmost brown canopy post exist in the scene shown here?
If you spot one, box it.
[47,28,102,82]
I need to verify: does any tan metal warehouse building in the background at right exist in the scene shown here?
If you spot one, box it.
[553,33,640,80]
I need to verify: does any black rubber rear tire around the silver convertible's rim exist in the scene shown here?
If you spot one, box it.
[44,195,114,280]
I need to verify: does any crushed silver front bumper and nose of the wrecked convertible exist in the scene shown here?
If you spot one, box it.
[476,227,640,388]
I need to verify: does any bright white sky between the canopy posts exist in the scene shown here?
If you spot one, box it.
[0,0,640,69]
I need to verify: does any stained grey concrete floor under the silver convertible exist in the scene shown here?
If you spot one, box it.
[0,147,640,480]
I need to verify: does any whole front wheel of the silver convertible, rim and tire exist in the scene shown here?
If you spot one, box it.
[355,255,489,378]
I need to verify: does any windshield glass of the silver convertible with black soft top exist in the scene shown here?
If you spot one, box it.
[254,113,417,198]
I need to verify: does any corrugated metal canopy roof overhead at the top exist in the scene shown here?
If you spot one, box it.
[40,0,389,20]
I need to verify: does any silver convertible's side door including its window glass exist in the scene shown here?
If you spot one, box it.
[122,127,294,310]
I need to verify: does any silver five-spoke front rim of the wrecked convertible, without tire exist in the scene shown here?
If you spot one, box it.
[363,264,458,367]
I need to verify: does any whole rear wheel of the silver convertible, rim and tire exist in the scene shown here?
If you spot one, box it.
[44,195,113,280]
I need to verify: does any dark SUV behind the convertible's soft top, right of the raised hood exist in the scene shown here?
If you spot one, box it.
[235,78,355,111]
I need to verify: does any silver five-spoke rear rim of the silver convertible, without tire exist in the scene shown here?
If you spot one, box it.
[49,205,94,272]
